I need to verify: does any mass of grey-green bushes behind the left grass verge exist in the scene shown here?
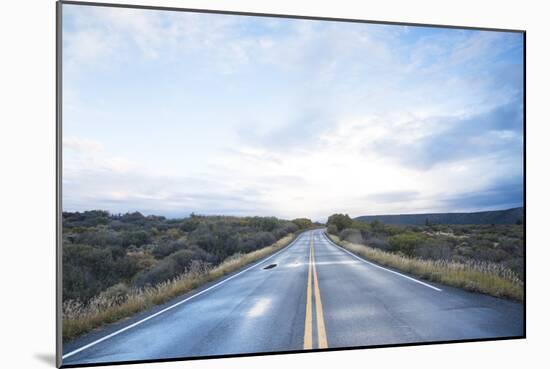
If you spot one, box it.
[63,211,300,303]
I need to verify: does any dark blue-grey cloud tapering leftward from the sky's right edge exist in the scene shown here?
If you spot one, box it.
[366,101,523,169]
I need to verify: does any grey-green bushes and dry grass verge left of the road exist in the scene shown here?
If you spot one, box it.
[63,211,311,340]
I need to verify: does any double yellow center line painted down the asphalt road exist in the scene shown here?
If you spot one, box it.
[304,236,328,350]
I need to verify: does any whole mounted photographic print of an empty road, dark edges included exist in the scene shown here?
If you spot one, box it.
[57,1,525,367]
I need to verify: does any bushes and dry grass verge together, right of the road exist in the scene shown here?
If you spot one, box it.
[327,214,524,301]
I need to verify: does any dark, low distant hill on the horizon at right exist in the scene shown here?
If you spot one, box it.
[355,207,523,225]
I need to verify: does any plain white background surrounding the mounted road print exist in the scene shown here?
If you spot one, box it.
[0,0,550,369]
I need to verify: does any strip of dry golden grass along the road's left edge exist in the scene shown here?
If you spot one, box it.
[63,234,294,340]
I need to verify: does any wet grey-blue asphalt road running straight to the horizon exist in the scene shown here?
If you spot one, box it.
[63,230,524,365]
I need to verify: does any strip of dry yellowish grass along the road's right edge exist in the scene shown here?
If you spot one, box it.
[329,234,524,301]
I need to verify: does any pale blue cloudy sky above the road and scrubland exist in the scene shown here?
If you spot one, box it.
[62,4,524,221]
